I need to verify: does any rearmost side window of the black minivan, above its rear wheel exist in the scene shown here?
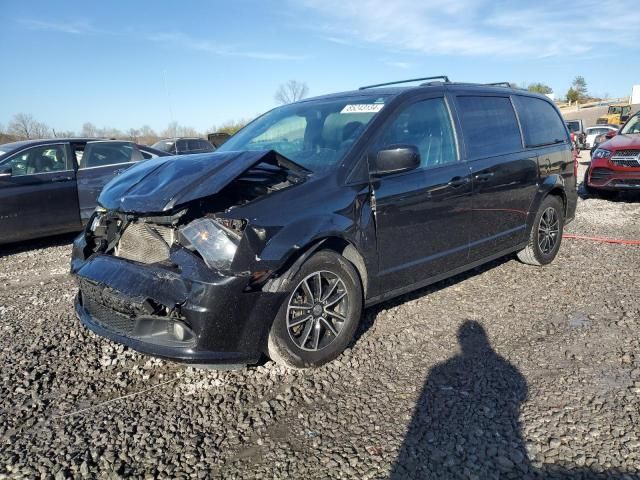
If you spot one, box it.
[513,96,567,147]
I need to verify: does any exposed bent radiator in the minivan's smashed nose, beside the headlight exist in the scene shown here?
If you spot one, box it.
[114,222,174,263]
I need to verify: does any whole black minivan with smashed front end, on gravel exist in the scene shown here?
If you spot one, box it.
[72,77,577,367]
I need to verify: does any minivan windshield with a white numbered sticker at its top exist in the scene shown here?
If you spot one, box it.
[217,95,386,172]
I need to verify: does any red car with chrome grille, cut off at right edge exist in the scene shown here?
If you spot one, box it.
[584,112,640,197]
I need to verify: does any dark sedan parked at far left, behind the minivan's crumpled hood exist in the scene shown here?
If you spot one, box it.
[0,138,167,243]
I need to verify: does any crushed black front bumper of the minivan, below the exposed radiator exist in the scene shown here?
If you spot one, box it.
[71,237,285,364]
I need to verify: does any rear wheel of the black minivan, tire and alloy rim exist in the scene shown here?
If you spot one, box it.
[518,195,564,266]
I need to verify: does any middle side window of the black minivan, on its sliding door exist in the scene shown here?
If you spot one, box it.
[458,96,522,158]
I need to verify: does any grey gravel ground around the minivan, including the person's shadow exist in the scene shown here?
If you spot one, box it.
[0,154,640,479]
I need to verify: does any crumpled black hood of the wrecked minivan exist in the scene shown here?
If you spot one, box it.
[98,151,307,213]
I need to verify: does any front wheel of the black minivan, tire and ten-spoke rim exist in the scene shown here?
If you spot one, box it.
[267,250,363,368]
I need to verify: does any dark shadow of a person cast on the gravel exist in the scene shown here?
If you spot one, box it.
[390,320,637,480]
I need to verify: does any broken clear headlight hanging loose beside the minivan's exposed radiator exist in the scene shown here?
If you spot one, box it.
[179,218,240,270]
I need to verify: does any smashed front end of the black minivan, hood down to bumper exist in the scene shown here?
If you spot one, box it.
[71,151,309,364]
